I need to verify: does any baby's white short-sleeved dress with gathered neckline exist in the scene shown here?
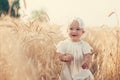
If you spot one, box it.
[57,39,92,80]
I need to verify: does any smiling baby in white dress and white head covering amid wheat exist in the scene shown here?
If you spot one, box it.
[57,18,93,80]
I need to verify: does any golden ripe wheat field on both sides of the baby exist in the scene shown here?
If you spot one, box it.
[0,17,120,80]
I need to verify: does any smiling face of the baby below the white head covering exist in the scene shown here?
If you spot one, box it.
[68,20,84,42]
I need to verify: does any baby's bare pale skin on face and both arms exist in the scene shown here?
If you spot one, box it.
[58,20,91,69]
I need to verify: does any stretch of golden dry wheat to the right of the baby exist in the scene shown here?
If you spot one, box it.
[85,27,120,80]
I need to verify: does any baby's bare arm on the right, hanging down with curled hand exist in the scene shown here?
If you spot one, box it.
[82,53,92,69]
